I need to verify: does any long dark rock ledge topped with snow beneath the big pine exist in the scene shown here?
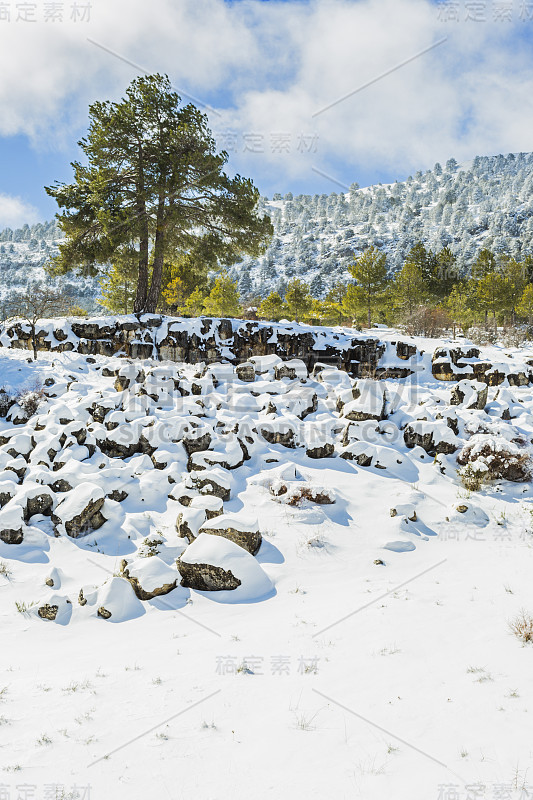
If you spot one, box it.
[0,315,394,377]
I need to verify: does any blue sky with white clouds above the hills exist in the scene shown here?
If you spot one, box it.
[0,0,533,228]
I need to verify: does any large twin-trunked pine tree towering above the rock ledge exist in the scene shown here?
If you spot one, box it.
[46,75,272,312]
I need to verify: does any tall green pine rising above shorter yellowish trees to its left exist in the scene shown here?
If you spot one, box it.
[343,246,388,328]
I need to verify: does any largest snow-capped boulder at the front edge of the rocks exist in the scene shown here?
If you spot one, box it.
[177,533,273,602]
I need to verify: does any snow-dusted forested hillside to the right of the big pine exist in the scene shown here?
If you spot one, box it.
[233,153,533,296]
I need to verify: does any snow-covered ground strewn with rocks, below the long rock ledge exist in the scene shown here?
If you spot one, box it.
[0,332,533,800]
